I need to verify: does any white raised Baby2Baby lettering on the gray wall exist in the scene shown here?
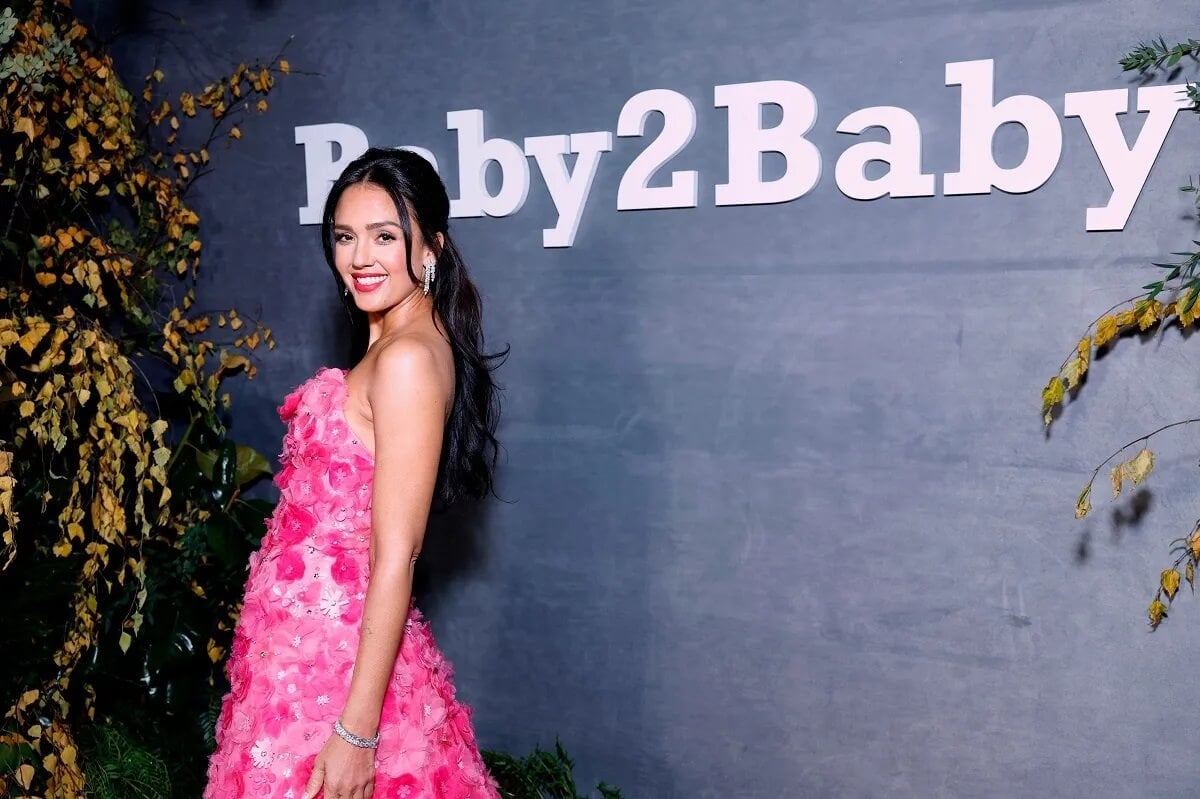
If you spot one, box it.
[295,59,1189,247]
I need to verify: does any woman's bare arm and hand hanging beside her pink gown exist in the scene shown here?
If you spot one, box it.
[305,338,450,799]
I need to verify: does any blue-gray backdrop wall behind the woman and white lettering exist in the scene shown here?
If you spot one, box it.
[91,0,1200,799]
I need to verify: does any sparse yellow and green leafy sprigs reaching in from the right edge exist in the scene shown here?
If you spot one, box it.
[1042,38,1200,630]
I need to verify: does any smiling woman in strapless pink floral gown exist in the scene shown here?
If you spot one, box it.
[204,149,498,799]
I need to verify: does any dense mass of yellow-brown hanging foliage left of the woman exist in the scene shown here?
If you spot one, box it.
[0,0,287,797]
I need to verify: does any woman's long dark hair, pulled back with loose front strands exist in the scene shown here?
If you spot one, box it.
[320,148,509,505]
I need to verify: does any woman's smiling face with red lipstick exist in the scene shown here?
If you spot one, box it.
[334,184,433,313]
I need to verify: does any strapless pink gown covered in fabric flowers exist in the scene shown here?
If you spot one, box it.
[204,370,498,799]
